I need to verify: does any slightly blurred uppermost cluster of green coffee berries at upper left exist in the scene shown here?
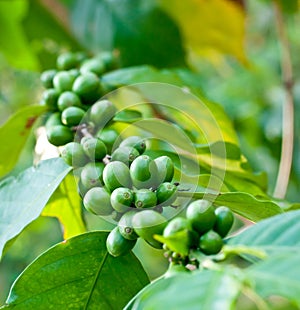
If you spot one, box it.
[41,52,118,146]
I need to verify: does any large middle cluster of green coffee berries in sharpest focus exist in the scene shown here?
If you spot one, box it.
[67,136,177,256]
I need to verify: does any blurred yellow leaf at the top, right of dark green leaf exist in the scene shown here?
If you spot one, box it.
[159,0,245,62]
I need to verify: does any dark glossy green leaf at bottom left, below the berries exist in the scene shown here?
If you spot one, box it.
[6,232,149,309]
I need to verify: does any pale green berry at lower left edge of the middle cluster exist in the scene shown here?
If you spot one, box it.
[83,187,113,216]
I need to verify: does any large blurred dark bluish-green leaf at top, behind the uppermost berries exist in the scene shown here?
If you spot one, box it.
[71,0,185,67]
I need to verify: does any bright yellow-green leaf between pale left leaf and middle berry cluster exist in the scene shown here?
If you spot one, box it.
[42,174,86,239]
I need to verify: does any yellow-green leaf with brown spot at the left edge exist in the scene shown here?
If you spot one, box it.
[0,105,47,177]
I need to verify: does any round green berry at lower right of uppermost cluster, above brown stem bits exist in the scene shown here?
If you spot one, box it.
[90,100,116,128]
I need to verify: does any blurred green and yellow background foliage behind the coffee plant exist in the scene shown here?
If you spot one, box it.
[0,0,300,303]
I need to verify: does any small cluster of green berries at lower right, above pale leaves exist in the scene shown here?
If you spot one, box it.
[162,199,234,264]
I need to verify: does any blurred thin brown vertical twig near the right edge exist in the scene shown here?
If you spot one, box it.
[273,1,294,198]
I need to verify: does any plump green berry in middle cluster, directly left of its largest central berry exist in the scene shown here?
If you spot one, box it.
[103,161,132,192]
